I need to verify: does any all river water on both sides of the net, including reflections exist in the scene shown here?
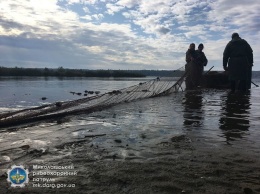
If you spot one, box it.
[0,77,260,191]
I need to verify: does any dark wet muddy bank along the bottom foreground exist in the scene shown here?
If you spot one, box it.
[0,135,260,194]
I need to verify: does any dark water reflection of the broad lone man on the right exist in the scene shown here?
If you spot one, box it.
[219,93,251,143]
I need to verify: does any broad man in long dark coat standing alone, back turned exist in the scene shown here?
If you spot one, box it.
[223,33,253,92]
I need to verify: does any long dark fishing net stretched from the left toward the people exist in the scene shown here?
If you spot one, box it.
[0,71,186,127]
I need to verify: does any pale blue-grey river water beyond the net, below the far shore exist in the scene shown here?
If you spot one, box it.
[0,77,154,112]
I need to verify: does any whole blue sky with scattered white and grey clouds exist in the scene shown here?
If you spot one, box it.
[0,0,260,70]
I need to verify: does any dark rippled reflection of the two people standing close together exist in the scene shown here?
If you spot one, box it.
[183,90,204,127]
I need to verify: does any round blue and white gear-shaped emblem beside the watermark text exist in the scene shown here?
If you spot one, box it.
[7,165,29,187]
